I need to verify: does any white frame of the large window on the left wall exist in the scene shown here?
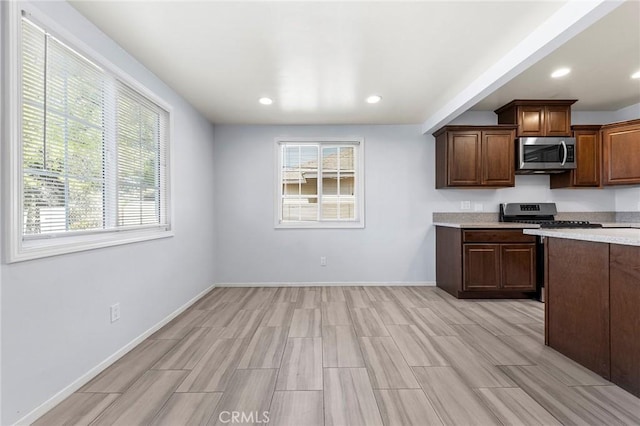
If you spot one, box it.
[1,2,174,263]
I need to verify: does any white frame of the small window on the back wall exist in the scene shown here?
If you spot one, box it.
[274,136,365,229]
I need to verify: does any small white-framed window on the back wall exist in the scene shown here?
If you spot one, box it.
[276,139,364,228]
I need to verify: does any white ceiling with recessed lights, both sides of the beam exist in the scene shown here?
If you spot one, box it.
[70,0,640,124]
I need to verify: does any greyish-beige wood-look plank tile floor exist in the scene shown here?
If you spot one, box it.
[34,287,640,426]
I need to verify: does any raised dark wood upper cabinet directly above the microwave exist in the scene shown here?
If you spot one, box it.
[495,99,576,137]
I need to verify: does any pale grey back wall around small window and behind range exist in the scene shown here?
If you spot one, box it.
[214,121,615,284]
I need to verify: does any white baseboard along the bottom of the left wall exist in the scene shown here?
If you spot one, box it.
[14,285,217,426]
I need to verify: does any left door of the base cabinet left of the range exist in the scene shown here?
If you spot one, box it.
[463,244,500,290]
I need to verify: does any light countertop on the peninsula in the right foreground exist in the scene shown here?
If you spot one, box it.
[522,228,640,246]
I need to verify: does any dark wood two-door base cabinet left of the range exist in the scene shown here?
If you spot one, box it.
[436,226,536,298]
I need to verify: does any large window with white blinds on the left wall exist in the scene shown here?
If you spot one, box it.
[9,12,170,261]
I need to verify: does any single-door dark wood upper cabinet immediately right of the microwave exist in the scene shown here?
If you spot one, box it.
[550,125,602,189]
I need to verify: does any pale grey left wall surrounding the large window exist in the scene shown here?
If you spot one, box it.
[0,2,214,425]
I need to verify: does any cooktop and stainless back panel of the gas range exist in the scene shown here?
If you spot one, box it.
[500,203,602,228]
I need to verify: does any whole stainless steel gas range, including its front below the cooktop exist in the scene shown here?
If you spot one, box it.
[500,203,602,302]
